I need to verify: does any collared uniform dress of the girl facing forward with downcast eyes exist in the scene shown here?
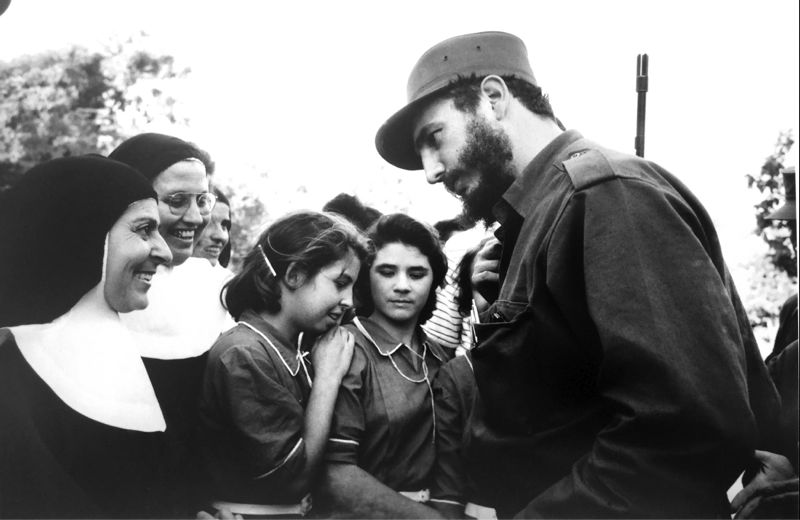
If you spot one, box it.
[325,318,448,494]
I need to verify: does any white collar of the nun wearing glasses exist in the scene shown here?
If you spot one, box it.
[120,257,235,359]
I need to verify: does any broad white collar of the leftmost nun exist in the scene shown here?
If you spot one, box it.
[9,282,166,432]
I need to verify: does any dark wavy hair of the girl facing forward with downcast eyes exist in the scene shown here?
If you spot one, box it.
[356,213,447,324]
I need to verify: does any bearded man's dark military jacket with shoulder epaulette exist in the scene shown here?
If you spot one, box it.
[468,131,778,518]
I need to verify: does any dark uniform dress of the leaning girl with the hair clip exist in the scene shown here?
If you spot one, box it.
[195,311,312,515]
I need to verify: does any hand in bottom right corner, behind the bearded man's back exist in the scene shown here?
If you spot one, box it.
[731,450,800,518]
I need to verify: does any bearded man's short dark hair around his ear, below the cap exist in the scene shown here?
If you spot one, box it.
[441,74,564,130]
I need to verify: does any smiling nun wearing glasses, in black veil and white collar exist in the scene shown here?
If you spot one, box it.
[109,133,233,517]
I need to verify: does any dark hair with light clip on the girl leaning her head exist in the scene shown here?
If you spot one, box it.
[222,211,369,320]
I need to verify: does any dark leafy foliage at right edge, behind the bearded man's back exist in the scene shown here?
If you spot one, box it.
[746,130,797,279]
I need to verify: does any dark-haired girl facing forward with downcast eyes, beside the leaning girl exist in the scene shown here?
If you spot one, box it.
[321,214,454,518]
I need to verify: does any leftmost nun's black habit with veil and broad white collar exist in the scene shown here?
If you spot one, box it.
[0,157,165,518]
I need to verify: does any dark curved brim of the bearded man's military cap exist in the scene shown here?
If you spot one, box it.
[375,87,444,170]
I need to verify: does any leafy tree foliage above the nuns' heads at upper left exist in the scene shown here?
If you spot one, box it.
[0,35,190,190]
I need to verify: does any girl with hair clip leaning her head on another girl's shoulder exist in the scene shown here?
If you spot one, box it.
[200,212,367,516]
